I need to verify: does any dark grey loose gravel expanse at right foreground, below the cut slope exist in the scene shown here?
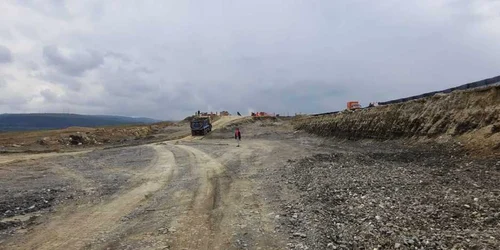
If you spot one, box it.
[279,149,500,249]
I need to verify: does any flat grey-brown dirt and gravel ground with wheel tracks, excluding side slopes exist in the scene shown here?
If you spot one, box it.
[0,118,500,249]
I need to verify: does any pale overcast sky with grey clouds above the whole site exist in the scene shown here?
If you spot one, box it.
[0,0,500,120]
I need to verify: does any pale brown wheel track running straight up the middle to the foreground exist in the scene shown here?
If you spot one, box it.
[166,142,285,249]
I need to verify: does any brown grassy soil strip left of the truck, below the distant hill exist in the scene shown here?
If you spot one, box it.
[0,122,184,154]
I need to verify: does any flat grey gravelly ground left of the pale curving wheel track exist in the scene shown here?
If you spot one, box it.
[0,147,154,240]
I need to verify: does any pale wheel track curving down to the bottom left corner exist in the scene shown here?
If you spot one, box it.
[8,146,175,249]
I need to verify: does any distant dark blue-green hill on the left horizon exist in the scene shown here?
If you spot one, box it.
[0,113,158,132]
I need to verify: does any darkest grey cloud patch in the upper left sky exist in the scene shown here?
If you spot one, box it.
[43,46,104,76]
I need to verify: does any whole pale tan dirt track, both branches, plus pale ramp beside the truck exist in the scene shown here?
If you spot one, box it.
[0,117,294,249]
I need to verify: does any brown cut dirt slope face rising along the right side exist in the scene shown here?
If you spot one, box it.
[295,86,500,152]
